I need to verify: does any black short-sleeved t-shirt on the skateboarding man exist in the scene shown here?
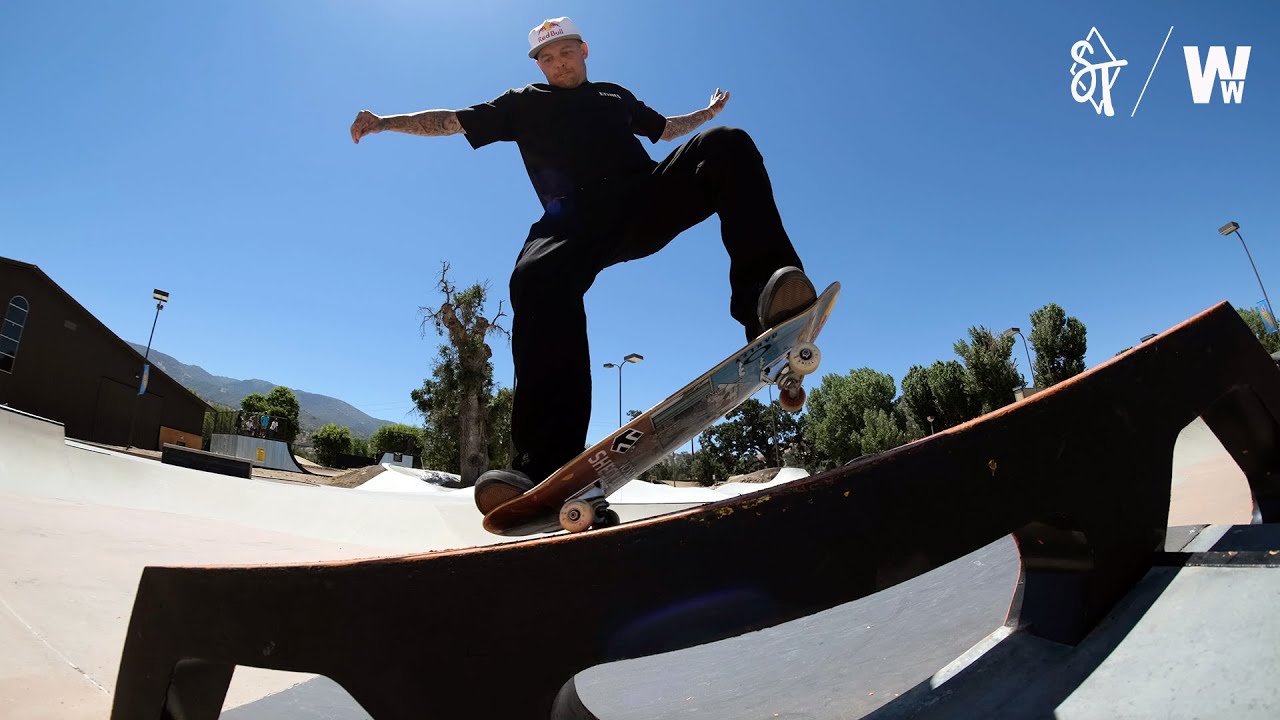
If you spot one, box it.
[457,82,667,206]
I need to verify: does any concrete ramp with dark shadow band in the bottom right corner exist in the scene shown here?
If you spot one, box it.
[869,524,1280,720]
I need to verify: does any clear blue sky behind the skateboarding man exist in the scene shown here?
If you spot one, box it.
[0,0,1280,441]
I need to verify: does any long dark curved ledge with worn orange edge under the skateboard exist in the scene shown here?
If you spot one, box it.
[113,304,1280,720]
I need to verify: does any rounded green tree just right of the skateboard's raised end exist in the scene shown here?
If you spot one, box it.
[805,368,904,465]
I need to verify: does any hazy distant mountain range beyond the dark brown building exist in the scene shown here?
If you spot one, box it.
[129,342,392,438]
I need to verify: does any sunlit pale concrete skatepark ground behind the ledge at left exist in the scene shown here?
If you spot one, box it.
[0,406,795,717]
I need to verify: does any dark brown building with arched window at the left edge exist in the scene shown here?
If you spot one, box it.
[0,258,210,450]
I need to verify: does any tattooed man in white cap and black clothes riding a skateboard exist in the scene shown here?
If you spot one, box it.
[351,18,815,512]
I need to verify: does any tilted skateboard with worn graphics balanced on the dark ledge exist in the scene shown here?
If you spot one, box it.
[484,282,840,536]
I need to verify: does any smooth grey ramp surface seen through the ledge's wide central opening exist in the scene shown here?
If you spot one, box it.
[575,538,1018,720]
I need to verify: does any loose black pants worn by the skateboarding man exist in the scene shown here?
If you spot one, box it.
[511,128,801,482]
